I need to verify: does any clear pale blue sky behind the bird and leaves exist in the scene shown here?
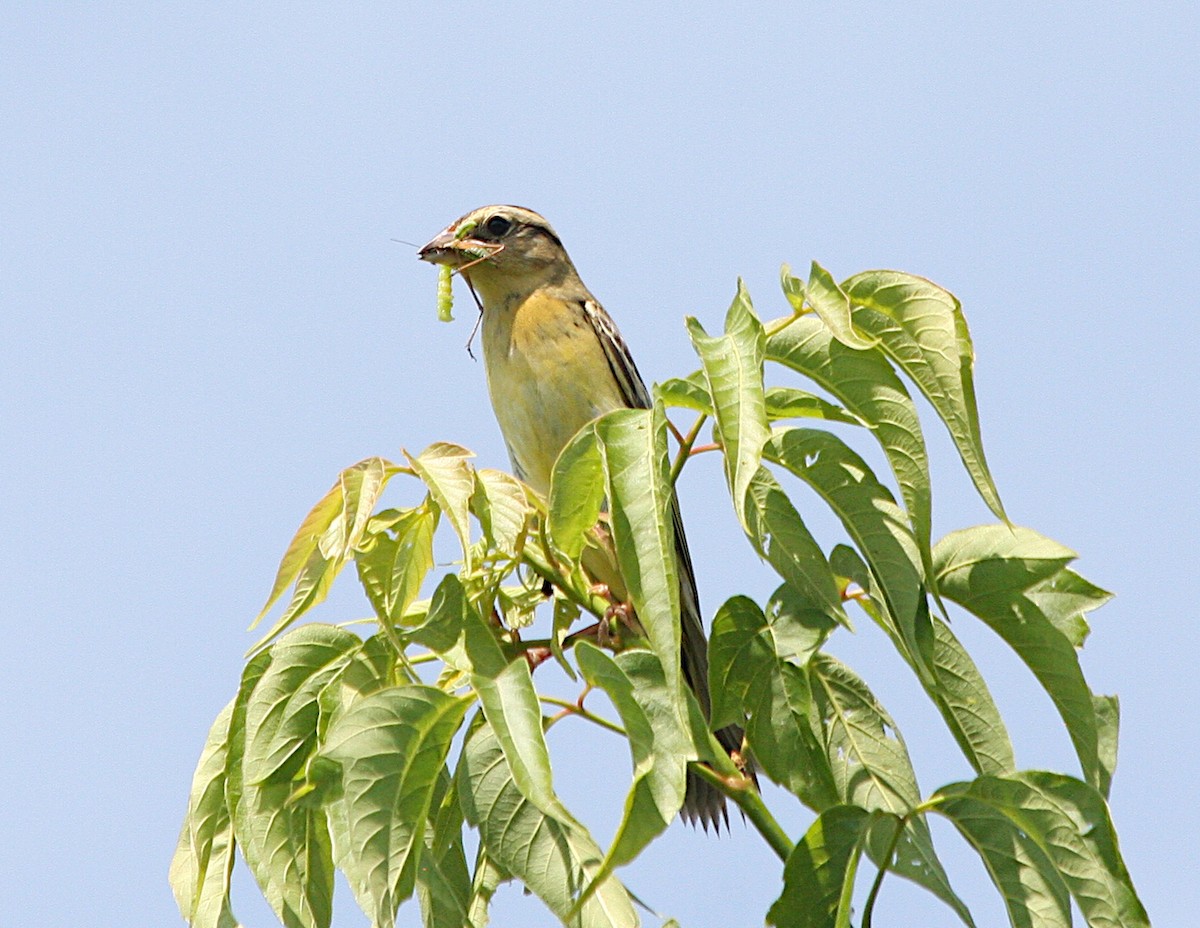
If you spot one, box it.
[0,2,1200,928]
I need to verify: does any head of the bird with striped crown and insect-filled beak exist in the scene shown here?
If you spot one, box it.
[418,206,576,306]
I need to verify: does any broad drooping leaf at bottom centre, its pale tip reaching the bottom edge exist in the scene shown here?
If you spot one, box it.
[456,723,640,928]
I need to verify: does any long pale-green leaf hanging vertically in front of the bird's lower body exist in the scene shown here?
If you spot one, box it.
[595,406,680,701]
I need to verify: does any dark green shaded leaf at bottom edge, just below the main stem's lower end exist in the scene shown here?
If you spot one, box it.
[767,806,883,928]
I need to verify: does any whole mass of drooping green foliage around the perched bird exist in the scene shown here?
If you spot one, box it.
[170,264,1148,928]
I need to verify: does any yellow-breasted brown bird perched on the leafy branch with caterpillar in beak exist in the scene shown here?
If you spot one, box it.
[418,205,752,832]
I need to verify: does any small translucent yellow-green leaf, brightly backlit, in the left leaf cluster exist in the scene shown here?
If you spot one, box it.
[354,498,438,624]
